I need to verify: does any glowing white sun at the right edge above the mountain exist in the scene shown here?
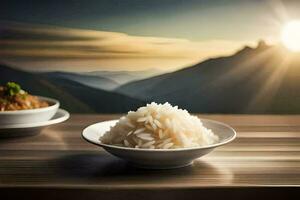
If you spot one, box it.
[281,20,300,52]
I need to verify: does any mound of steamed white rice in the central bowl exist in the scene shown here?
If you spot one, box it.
[100,103,218,149]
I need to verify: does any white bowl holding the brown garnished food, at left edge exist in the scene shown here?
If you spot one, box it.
[0,96,59,125]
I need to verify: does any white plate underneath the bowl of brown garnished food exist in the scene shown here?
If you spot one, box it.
[0,109,70,137]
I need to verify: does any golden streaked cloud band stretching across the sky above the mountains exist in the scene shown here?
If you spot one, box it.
[0,23,251,72]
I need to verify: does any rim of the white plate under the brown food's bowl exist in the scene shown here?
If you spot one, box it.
[0,108,70,130]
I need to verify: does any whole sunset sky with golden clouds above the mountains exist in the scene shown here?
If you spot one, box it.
[0,0,300,71]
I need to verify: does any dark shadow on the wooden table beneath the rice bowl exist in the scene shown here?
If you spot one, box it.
[55,154,233,181]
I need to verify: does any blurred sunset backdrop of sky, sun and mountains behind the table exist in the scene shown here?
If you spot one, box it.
[0,0,300,114]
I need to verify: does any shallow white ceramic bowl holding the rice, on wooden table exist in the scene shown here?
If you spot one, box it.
[82,119,236,169]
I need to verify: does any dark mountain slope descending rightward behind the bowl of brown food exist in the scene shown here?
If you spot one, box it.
[0,64,144,113]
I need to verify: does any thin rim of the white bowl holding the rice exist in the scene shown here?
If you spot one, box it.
[81,117,237,152]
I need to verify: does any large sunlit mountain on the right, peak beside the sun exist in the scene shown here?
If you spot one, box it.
[116,41,300,113]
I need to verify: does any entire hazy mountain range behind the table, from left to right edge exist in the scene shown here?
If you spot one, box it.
[0,42,300,114]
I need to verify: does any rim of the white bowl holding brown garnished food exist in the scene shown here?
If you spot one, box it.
[0,95,60,116]
